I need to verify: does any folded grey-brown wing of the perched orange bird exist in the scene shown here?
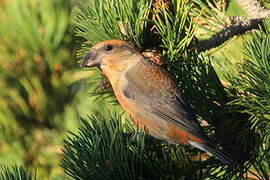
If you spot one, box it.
[123,58,205,139]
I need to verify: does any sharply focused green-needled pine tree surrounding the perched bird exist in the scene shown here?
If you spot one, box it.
[62,0,270,179]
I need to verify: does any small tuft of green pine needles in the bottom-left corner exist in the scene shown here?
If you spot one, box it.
[0,166,36,180]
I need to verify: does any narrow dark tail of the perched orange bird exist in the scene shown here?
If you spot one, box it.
[189,141,236,166]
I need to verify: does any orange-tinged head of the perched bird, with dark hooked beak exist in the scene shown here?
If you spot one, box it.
[82,40,138,70]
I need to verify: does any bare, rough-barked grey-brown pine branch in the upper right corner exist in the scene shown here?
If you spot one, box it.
[194,0,270,52]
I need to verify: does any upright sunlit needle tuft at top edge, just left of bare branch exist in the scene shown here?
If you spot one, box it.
[154,0,195,58]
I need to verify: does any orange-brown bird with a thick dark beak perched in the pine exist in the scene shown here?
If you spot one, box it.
[81,39,234,165]
